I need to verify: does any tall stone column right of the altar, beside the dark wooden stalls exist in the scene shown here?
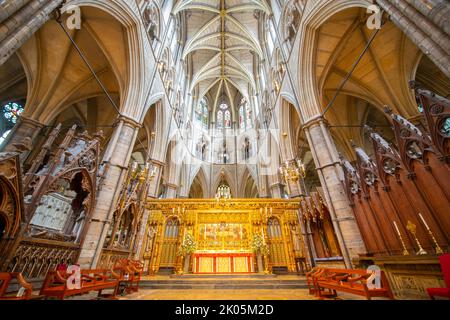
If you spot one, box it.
[304,117,366,267]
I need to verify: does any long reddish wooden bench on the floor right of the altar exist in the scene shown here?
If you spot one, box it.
[312,268,394,300]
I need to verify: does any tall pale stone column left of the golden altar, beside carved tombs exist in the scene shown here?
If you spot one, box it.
[78,116,140,269]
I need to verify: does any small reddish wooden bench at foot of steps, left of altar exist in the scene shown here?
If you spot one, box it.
[111,259,144,293]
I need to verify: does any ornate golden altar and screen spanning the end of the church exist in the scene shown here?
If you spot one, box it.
[143,199,304,275]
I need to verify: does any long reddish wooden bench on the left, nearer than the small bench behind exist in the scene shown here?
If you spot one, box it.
[40,269,118,299]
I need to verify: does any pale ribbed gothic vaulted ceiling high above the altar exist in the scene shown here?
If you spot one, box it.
[174,0,271,114]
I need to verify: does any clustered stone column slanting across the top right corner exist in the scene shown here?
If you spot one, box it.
[376,0,450,78]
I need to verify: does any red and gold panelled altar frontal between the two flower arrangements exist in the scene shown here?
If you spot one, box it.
[193,252,255,273]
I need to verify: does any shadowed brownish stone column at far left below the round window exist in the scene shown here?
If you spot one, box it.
[1,116,44,163]
